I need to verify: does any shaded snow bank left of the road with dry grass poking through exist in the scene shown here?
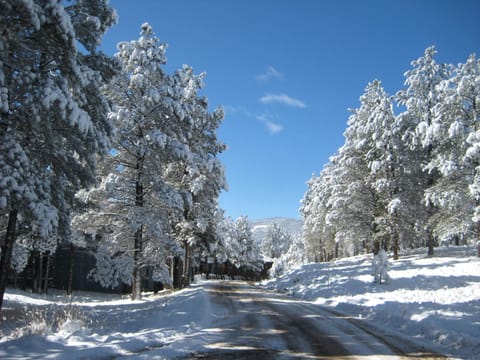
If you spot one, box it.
[0,286,212,359]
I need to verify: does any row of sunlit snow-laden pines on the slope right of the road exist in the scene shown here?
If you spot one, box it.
[300,47,480,261]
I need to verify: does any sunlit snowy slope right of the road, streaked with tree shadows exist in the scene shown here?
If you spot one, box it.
[264,247,480,359]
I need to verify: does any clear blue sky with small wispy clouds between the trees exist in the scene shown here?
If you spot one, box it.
[102,0,480,219]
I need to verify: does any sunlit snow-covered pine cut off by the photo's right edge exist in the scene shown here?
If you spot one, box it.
[427,55,480,244]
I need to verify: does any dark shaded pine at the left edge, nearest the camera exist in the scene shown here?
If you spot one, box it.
[0,0,116,306]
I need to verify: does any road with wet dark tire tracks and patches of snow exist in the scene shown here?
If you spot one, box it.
[188,282,441,359]
